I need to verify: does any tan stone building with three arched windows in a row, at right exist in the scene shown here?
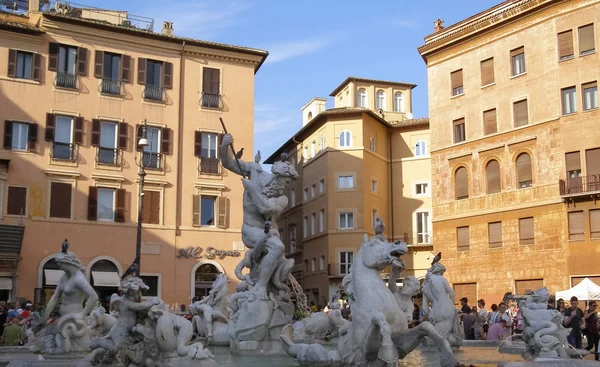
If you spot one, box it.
[419,0,600,304]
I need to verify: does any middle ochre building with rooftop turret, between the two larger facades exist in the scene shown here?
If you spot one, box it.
[265,77,432,306]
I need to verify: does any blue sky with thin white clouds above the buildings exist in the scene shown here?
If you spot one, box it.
[82,0,501,159]
